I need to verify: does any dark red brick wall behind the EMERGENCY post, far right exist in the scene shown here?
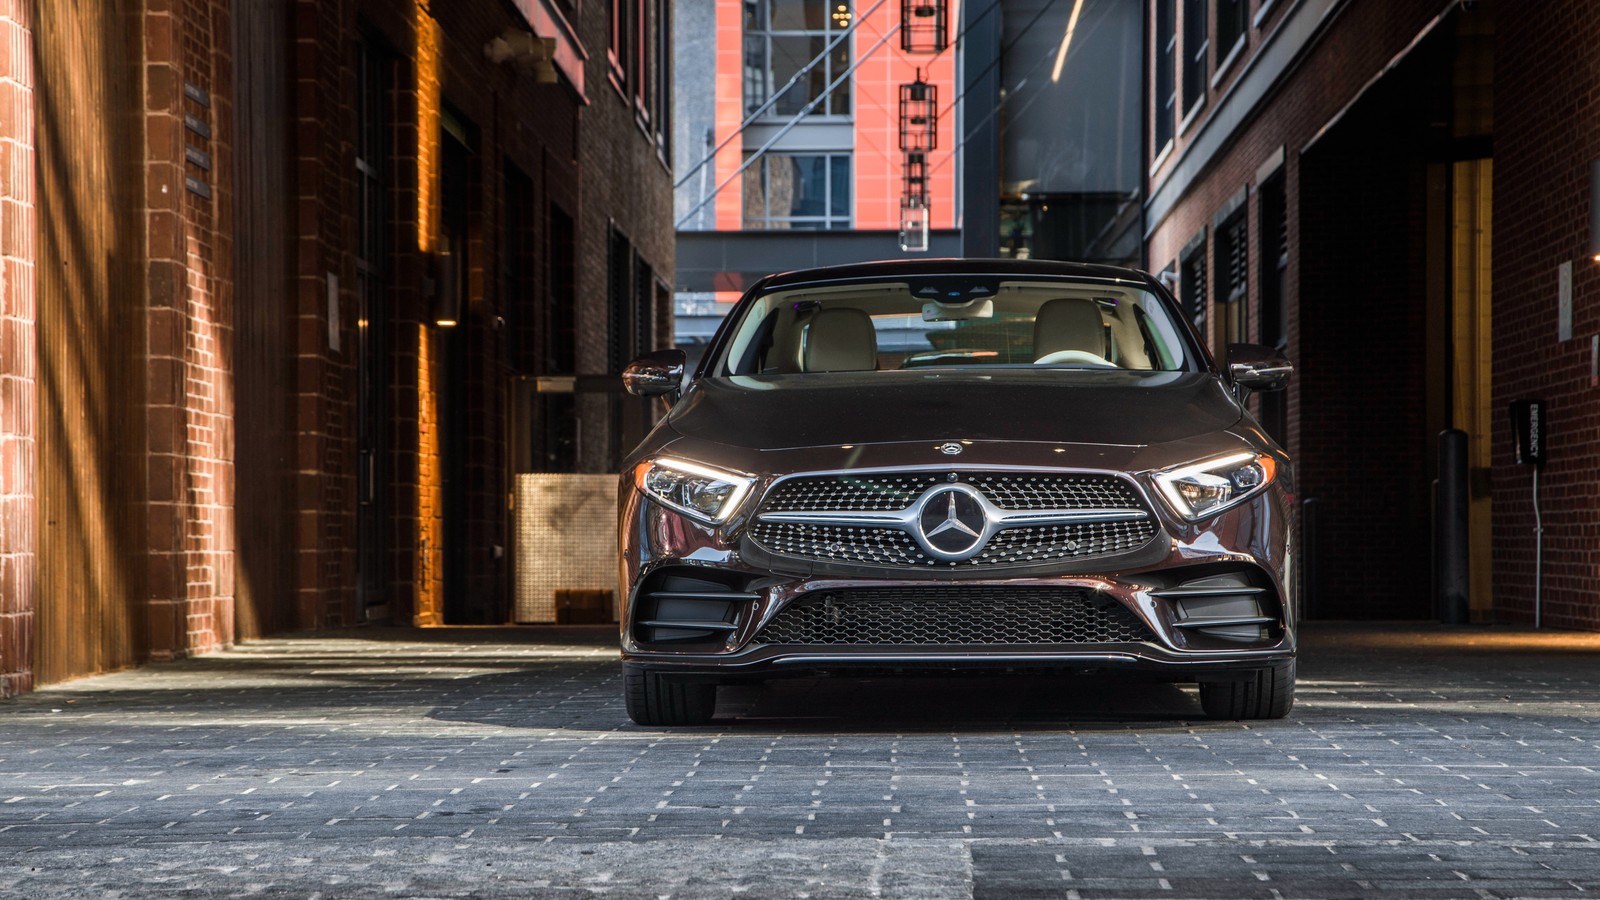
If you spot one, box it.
[1493,0,1600,629]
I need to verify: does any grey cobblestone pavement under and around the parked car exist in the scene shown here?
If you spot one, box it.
[0,625,1600,898]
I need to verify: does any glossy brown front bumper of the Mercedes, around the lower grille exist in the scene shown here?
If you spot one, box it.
[621,464,1296,681]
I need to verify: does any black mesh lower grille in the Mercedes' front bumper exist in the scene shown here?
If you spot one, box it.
[755,586,1155,647]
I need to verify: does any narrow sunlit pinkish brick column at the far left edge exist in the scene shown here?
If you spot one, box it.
[0,0,38,697]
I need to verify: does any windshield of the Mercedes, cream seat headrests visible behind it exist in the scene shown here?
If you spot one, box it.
[714,277,1194,375]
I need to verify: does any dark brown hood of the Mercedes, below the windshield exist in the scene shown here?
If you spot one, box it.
[667,370,1242,450]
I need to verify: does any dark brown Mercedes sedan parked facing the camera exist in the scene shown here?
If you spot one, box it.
[621,259,1294,725]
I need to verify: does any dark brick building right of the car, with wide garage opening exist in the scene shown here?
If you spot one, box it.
[1146,0,1600,628]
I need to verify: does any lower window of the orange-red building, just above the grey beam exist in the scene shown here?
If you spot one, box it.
[744,154,850,231]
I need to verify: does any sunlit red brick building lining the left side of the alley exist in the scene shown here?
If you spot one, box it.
[0,0,672,695]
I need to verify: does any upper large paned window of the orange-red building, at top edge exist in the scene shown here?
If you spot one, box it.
[744,0,851,117]
